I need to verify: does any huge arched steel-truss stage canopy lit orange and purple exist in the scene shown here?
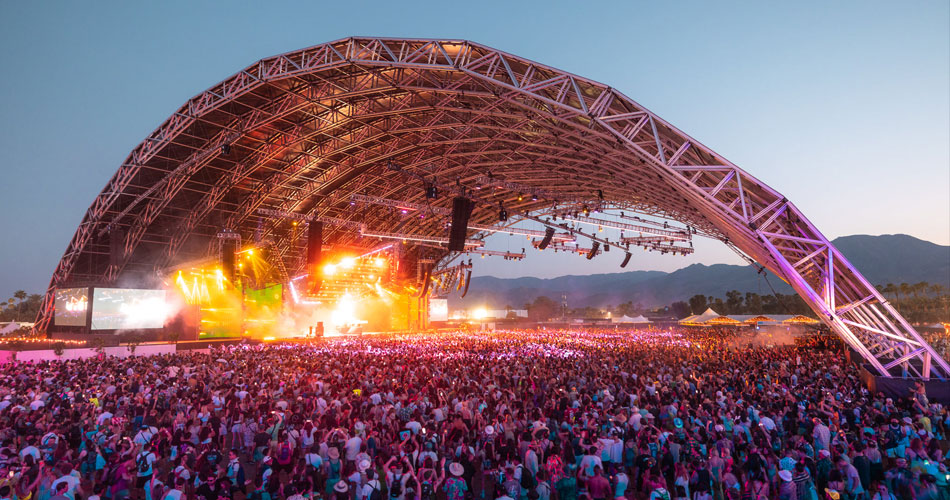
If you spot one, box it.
[38,38,950,378]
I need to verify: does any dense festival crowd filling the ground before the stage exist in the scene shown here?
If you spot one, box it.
[0,331,950,500]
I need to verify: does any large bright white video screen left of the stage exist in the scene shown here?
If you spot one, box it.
[92,288,167,330]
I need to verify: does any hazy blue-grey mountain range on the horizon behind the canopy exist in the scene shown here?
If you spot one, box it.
[449,234,950,309]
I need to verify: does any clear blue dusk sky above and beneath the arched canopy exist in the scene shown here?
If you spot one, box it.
[0,0,950,298]
